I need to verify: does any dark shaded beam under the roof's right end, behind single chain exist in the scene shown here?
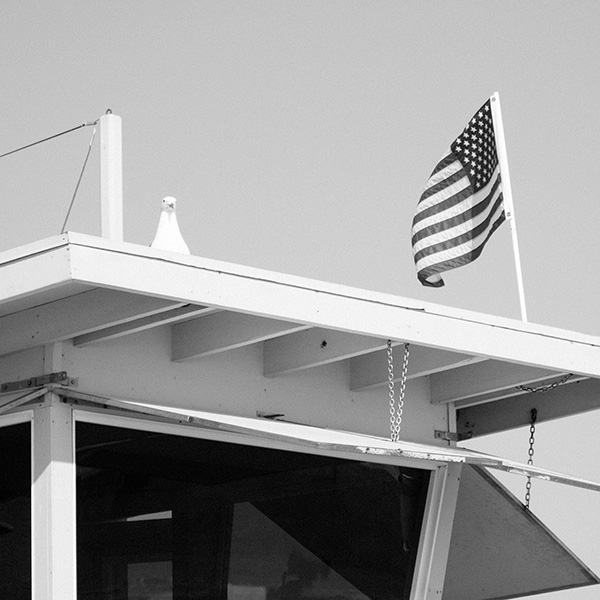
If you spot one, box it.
[457,379,600,437]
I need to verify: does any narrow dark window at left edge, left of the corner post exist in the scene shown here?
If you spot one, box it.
[0,423,31,600]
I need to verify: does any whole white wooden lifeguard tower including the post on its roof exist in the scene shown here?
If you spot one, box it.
[0,115,600,600]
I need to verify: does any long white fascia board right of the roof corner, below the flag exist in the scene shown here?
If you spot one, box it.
[62,237,600,377]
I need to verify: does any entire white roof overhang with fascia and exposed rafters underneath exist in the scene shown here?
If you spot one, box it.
[0,233,600,436]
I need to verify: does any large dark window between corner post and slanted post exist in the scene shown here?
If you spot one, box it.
[77,423,429,600]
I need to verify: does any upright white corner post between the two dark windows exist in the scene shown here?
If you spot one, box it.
[32,394,77,600]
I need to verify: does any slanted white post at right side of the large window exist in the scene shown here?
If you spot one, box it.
[410,464,462,600]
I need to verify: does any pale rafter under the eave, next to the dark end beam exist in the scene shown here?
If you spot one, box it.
[430,360,564,403]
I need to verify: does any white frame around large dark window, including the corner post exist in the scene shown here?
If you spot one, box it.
[0,391,462,600]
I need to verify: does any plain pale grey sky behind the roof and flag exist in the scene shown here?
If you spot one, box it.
[0,0,600,600]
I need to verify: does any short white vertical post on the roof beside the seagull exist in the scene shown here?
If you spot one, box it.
[100,112,123,242]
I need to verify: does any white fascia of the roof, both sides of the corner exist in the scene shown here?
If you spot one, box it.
[0,233,600,370]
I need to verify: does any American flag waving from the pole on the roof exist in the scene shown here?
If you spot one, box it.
[412,100,506,287]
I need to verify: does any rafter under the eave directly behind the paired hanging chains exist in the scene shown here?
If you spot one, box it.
[350,344,487,391]
